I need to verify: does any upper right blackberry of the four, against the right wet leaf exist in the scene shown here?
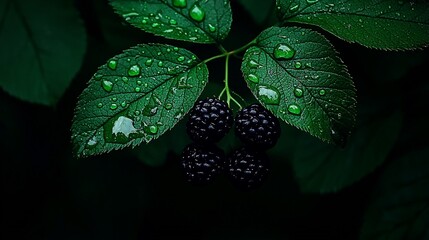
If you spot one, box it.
[235,104,280,149]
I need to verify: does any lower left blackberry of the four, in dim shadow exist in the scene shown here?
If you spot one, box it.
[180,143,225,185]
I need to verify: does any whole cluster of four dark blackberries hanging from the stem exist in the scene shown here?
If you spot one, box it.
[181,98,280,189]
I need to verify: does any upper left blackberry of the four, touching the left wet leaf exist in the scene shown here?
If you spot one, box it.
[186,98,234,143]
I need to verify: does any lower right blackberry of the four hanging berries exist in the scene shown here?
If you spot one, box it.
[227,146,270,190]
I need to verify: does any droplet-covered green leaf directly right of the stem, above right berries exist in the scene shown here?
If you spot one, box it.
[241,27,356,145]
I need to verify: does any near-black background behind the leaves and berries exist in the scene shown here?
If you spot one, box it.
[0,0,429,240]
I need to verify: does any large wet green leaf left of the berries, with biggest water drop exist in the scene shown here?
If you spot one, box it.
[72,44,208,156]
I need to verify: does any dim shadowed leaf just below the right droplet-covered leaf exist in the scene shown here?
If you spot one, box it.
[291,112,402,193]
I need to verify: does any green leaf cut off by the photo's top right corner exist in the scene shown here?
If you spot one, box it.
[277,0,429,50]
